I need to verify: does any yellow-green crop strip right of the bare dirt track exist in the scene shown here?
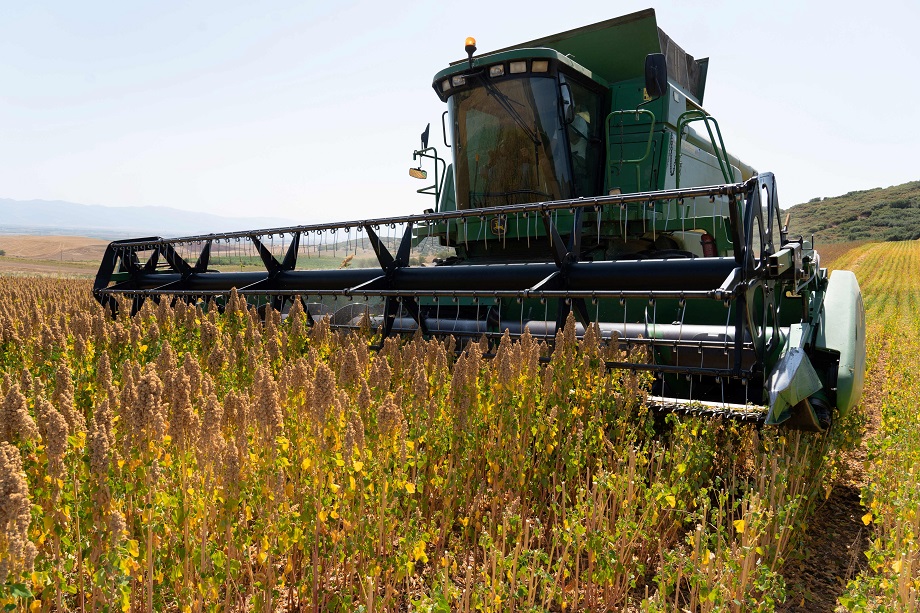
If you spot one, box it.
[835,241,920,611]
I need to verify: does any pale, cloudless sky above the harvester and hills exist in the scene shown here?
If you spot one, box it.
[0,0,920,224]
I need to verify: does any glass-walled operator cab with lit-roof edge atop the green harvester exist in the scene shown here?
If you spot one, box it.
[433,49,608,210]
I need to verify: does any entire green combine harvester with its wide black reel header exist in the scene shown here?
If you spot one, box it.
[94,10,865,430]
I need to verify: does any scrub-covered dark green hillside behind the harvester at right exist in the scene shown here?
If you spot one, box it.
[788,181,920,243]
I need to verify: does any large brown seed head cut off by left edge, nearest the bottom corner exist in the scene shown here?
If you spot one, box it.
[0,442,38,585]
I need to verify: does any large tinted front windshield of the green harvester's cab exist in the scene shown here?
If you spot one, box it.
[450,77,572,209]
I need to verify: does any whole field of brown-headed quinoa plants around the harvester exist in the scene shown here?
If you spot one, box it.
[0,242,920,613]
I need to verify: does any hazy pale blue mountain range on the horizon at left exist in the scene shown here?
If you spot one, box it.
[0,198,304,239]
